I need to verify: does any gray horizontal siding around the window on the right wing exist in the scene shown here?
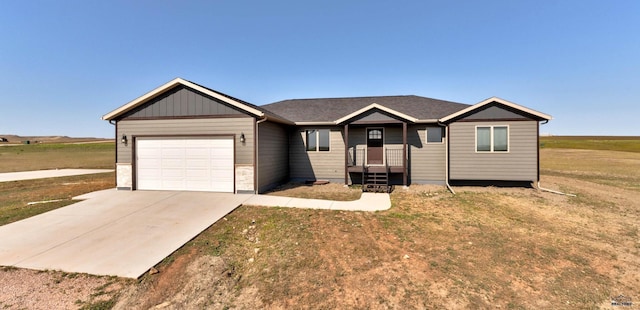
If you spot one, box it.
[449,121,538,181]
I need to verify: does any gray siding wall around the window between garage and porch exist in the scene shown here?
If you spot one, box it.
[289,126,345,182]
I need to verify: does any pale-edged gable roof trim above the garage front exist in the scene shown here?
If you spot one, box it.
[102,78,265,120]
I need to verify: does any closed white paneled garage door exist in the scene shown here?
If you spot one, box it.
[136,138,234,192]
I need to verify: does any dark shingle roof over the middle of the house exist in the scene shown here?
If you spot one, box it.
[261,95,470,122]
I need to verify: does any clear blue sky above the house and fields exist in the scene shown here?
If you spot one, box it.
[0,0,640,137]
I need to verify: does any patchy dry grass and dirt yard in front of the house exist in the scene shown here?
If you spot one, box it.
[0,149,640,309]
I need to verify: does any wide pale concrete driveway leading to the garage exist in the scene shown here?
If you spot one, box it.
[0,189,252,278]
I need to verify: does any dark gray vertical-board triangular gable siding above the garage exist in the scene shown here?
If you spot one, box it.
[123,85,244,119]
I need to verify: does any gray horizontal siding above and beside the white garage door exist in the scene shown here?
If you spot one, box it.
[116,117,254,165]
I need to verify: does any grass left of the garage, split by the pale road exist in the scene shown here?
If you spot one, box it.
[0,142,115,225]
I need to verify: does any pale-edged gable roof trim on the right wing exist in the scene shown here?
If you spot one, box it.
[440,97,552,123]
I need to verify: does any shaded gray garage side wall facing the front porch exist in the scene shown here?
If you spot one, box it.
[257,122,289,193]
